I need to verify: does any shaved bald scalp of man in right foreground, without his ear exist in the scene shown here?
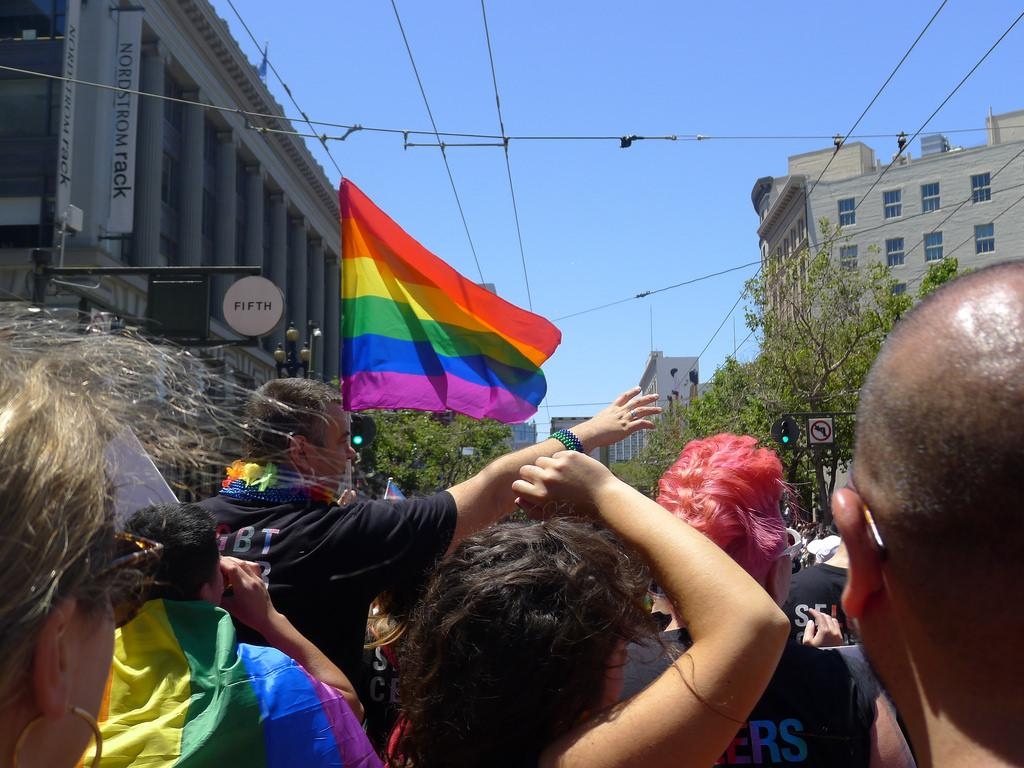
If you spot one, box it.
[854,262,1024,610]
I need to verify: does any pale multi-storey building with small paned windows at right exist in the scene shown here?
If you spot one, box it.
[751,111,1024,291]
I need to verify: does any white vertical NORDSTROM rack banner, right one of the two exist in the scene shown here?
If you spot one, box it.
[106,8,142,232]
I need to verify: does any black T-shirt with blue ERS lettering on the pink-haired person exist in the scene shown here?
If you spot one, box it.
[623,631,879,768]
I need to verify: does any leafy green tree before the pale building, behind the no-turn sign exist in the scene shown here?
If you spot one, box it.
[639,220,911,520]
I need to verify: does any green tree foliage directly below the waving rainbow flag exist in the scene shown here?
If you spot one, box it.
[360,411,512,496]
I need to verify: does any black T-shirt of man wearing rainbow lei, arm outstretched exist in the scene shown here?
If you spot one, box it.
[201,492,456,681]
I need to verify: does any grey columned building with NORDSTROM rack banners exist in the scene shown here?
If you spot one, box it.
[0,0,341,384]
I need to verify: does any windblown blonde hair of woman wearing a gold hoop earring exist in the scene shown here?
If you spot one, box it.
[0,304,241,706]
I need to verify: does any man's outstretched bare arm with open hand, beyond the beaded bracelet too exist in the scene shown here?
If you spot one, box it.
[449,387,662,552]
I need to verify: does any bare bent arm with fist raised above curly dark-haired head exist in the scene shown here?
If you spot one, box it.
[513,452,790,768]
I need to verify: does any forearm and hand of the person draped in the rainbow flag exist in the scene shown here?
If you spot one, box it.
[220,557,364,722]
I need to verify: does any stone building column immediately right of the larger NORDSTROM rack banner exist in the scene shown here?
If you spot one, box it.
[131,42,167,266]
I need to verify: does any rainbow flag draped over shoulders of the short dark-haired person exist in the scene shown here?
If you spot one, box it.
[91,600,381,768]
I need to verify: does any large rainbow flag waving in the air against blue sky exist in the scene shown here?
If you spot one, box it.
[339,179,561,423]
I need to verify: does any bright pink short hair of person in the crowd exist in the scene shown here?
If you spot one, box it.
[657,434,787,584]
